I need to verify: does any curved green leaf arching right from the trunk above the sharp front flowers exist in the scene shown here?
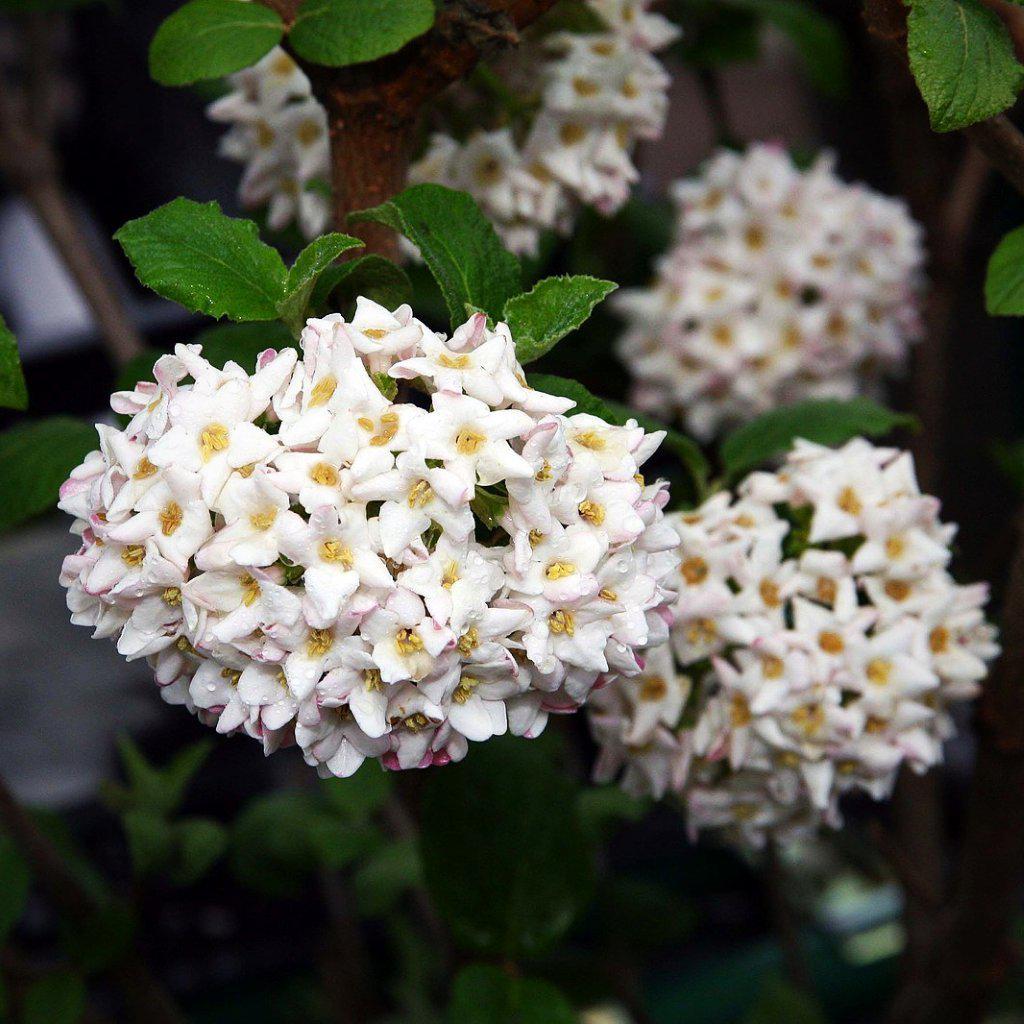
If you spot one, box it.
[349,184,522,328]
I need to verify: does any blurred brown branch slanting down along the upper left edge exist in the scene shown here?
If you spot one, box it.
[0,15,143,364]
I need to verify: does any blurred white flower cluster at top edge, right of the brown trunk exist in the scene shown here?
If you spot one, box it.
[410,0,678,254]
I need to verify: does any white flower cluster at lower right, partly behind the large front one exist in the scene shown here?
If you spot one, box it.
[590,439,998,844]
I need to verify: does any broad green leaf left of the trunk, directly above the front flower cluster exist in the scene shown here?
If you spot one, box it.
[114,194,288,321]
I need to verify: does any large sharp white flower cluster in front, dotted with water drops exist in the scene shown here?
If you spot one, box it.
[60,298,679,776]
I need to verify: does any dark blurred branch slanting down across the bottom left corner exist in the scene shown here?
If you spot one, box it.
[0,776,184,1024]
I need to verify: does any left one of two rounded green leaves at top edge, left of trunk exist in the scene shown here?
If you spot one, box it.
[150,0,285,85]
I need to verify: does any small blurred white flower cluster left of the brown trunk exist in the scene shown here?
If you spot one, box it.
[207,47,330,239]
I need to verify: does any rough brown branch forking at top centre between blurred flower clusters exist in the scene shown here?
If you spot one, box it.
[294,0,556,258]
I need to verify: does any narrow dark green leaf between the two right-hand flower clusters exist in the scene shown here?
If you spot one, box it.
[721,398,916,479]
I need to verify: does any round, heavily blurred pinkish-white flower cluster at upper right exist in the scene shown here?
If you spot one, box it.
[615,144,924,438]
